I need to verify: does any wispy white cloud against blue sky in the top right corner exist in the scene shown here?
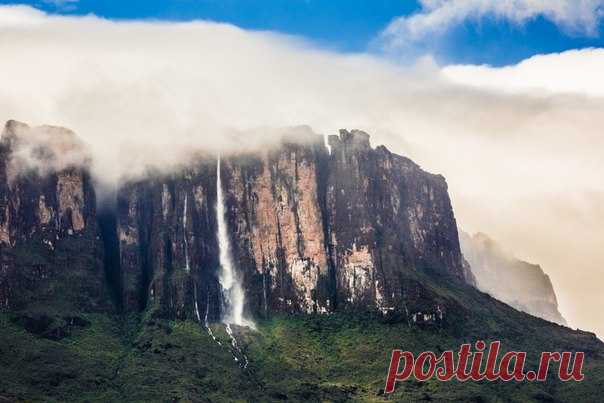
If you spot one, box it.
[382,0,604,49]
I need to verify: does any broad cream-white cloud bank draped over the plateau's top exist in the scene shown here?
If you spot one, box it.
[0,7,604,335]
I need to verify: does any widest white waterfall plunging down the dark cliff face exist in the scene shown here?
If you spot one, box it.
[216,158,255,328]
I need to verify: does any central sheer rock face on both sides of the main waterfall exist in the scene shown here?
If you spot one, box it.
[111,131,472,321]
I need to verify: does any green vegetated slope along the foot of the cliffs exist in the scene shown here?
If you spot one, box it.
[0,238,604,402]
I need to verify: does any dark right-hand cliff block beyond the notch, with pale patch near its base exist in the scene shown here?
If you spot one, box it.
[326,130,472,312]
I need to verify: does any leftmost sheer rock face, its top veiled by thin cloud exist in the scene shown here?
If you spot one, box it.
[0,121,96,245]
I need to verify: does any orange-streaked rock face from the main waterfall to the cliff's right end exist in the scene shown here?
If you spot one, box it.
[223,131,472,315]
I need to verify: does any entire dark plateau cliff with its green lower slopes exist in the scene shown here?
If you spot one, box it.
[0,121,604,402]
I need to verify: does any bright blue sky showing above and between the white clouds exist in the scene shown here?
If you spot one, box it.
[0,0,604,66]
